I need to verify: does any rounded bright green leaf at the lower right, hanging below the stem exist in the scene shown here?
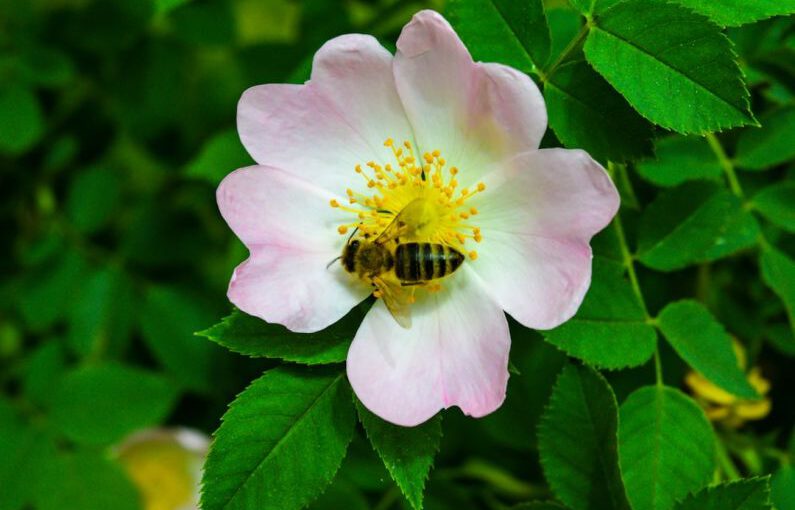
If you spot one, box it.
[618,386,715,510]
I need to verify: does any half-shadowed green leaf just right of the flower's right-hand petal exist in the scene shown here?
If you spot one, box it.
[638,182,759,271]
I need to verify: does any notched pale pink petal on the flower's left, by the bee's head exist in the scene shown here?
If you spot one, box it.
[217,166,370,332]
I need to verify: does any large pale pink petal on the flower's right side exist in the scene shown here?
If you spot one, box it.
[471,149,619,329]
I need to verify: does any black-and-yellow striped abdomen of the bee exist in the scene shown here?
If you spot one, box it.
[395,243,464,282]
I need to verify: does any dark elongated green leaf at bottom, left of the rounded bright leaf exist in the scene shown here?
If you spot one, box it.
[538,365,629,510]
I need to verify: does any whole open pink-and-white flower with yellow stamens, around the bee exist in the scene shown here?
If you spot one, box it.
[217,11,619,426]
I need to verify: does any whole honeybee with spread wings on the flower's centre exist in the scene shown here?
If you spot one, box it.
[340,199,465,328]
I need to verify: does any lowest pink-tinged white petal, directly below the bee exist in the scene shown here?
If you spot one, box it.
[348,269,511,427]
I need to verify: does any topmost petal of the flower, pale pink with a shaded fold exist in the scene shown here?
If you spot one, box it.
[394,11,547,186]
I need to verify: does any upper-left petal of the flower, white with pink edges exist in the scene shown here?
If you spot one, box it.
[237,34,412,193]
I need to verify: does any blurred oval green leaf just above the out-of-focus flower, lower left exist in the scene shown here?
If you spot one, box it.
[51,363,177,445]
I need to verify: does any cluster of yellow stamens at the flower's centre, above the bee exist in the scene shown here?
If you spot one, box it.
[331,138,486,260]
